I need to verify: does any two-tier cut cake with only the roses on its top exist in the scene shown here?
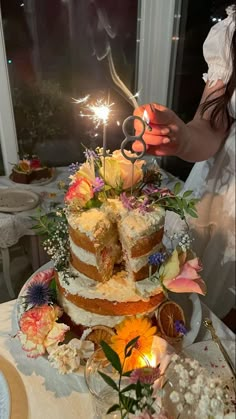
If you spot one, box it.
[56,150,165,334]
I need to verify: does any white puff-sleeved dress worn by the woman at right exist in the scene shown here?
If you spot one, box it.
[167,11,236,318]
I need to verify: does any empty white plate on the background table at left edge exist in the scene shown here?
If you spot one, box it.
[0,188,39,212]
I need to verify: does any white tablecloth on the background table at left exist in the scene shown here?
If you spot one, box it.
[0,167,69,248]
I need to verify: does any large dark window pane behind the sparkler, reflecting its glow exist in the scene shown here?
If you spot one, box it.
[0,0,138,165]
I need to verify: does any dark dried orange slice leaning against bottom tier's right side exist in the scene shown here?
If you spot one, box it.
[156,300,185,343]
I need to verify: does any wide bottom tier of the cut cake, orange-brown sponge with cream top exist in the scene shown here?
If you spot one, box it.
[56,268,165,316]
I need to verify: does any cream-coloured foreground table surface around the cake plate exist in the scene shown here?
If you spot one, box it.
[0,292,235,419]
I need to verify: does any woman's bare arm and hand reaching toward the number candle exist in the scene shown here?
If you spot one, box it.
[133,80,227,162]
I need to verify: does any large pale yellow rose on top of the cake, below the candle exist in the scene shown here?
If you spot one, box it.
[100,150,145,190]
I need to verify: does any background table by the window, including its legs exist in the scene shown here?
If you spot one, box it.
[0,167,69,298]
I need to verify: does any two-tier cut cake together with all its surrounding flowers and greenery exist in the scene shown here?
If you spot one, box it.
[17,150,205,362]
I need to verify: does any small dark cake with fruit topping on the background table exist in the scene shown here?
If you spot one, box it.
[10,155,53,184]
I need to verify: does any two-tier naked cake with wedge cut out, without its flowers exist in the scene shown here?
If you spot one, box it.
[57,198,165,332]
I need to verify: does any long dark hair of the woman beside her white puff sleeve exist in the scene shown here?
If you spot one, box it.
[200,11,236,131]
